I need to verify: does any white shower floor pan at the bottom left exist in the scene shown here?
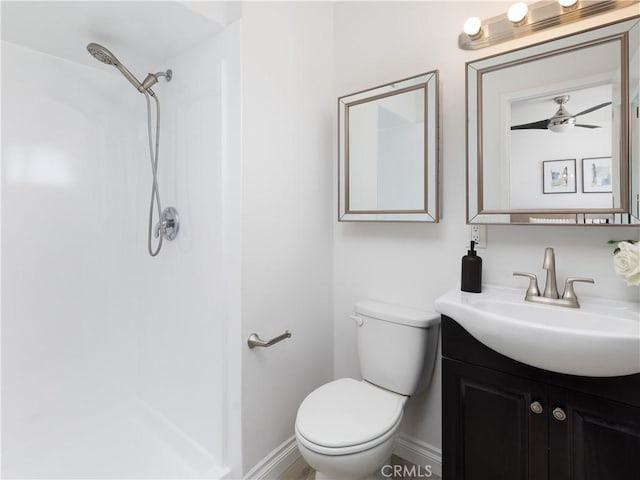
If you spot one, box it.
[2,403,228,480]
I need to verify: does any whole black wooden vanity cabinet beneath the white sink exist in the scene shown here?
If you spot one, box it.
[442,316,640,480]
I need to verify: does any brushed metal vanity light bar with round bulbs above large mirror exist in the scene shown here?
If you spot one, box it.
[458,0,638,50]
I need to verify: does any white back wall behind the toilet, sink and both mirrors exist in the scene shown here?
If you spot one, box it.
[334,2,640,464]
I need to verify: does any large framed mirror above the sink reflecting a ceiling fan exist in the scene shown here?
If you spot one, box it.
[466,17,640,226]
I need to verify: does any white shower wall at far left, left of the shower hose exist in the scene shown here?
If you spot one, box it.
[2,42,144,476]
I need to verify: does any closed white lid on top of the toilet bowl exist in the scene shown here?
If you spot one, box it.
[296,378,404,448]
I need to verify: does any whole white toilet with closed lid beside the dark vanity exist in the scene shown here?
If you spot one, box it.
[295,300,440,480]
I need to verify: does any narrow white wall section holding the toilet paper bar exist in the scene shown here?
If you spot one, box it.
[242,2,335,473]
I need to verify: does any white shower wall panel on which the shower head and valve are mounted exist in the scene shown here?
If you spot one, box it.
[132,19,241,474]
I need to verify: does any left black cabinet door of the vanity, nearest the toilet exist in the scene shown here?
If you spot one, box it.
[442,358,548,480]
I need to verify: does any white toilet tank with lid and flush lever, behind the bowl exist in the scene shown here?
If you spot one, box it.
[352,300,440,395]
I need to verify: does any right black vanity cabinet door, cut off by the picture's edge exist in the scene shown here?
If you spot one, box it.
[549,391,640,480]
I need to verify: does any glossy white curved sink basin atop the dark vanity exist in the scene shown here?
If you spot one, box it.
[435,285,640,377]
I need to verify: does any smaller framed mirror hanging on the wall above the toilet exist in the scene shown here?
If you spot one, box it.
[338,71,439,222]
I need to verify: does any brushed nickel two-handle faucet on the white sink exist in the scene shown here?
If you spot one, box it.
[513,247,595,308]
